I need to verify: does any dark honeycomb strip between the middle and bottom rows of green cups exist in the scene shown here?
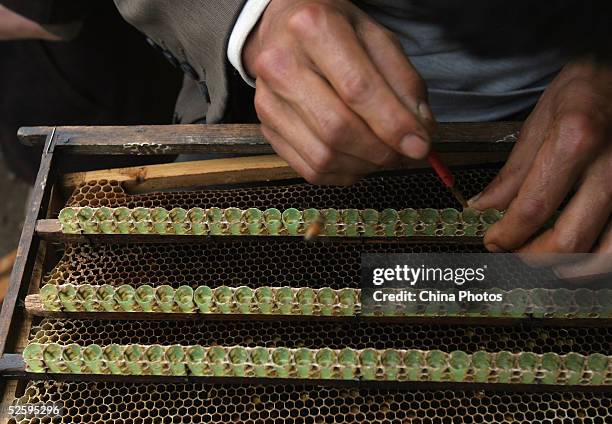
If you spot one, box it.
[30,318,612,355]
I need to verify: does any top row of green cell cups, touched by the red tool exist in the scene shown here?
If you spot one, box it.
[59,207,502,236]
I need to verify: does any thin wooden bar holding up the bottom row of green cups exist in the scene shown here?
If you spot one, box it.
[0,354,612,393]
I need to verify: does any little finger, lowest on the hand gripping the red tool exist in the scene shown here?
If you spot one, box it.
[261,124,361,186]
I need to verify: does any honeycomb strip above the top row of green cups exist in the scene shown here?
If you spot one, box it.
[66,167,498,210]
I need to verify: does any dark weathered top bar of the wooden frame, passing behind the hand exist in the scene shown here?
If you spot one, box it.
[18,122,521,155]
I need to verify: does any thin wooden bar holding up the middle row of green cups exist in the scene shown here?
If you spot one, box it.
[25,294,612,328]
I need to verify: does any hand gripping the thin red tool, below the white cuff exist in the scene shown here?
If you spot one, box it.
[243,0,435,185]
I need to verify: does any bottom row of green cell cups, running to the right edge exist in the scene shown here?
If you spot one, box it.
[23,343,612,386]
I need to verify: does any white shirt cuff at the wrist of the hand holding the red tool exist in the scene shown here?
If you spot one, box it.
[227,0,270,87]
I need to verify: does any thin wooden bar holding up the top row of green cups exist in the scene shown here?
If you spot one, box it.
[36,219,483,246]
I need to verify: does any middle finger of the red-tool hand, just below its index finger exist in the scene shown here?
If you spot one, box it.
[265,69,399,166]
